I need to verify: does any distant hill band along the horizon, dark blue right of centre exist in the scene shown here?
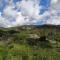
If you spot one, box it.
[0,24,60,30]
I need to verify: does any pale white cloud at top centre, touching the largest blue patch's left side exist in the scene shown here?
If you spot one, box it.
[17,0,40,18]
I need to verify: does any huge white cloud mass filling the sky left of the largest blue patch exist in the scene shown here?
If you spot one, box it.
[1,0,42,27]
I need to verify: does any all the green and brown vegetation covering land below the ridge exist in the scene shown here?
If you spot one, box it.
[0,26,60,60]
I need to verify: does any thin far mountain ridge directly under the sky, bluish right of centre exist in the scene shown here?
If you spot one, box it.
[0,24,60,29]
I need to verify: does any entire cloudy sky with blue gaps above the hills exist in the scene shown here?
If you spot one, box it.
[0,0,60,28]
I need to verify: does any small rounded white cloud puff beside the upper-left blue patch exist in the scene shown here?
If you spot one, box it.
[3,6,17,17]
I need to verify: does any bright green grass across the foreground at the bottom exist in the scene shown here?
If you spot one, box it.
[0,42,60,60]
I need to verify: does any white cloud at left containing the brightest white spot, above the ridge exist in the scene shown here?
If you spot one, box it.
[4,6,25,27]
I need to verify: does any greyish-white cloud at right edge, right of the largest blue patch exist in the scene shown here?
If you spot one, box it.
[46,0,60,25]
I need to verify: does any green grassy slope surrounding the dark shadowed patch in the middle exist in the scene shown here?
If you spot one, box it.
[0,27,60,60]
